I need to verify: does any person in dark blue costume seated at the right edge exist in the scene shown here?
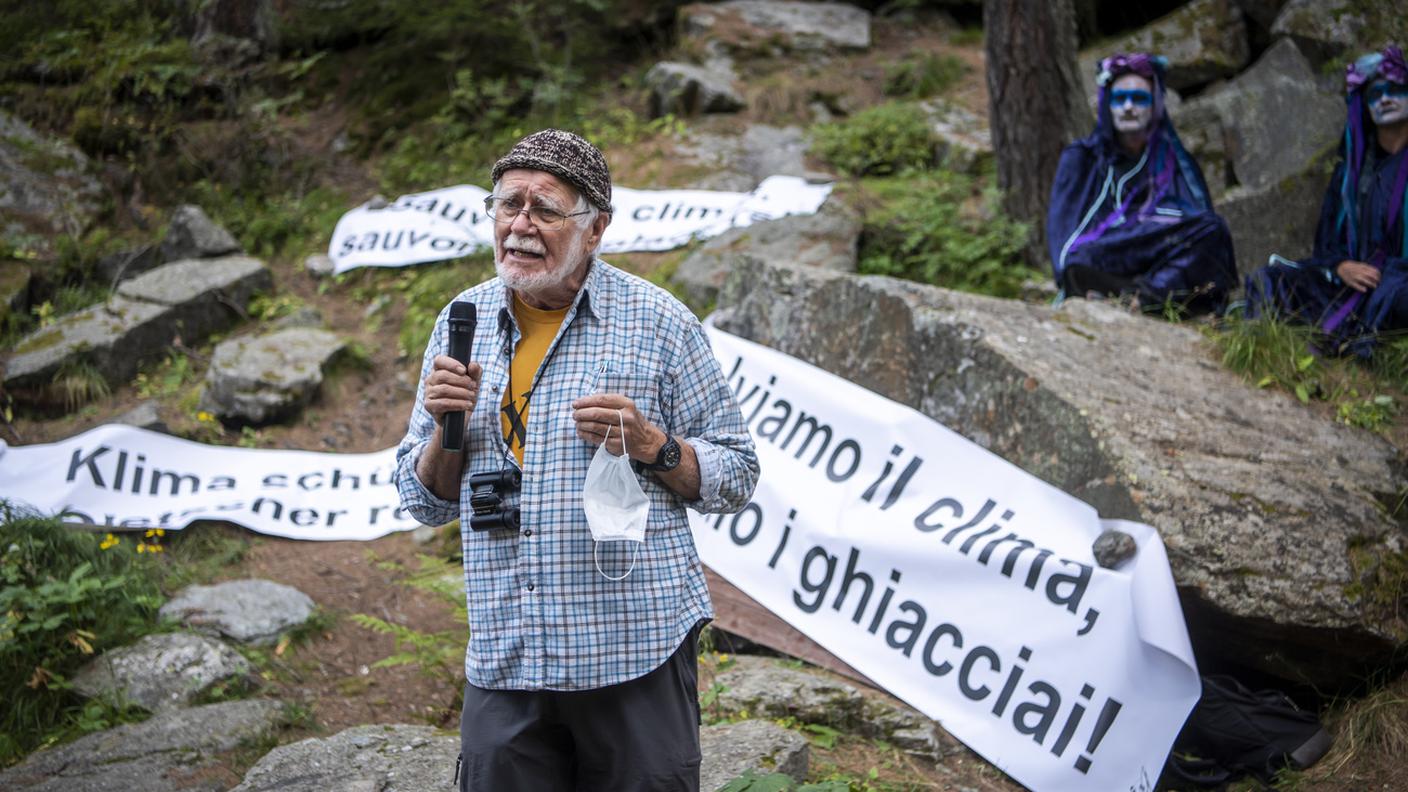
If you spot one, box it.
[1246,47,1408,350]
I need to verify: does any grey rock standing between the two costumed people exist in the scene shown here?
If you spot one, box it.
[1174,39,1345,196]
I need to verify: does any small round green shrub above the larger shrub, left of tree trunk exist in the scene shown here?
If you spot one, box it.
[812,101,935,176]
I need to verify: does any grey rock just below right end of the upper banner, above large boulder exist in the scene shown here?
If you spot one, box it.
[672,199,860,306]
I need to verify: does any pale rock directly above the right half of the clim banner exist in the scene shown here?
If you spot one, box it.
[679,124,825,193]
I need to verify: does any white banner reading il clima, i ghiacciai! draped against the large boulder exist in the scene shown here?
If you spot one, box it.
[690,327,1201,792]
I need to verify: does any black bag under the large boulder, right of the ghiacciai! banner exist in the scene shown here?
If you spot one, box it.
[1169,676,1331,786]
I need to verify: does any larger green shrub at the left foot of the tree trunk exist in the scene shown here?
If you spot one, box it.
[857,171,1035,297]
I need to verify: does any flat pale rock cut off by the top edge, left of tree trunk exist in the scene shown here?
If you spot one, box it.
[679,0,870,54]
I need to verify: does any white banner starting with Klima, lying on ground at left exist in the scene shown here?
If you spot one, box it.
[0,424,420,540]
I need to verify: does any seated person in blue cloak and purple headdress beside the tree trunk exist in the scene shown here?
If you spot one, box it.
[1046,52,1238,314]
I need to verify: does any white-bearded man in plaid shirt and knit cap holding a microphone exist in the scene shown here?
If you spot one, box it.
[397,130,758,792]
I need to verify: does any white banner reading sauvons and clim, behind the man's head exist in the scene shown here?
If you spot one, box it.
[328,176,831,272]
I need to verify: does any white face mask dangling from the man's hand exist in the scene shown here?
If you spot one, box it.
[582,410,650,581]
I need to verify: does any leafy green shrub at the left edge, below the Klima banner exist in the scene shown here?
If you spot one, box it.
[0,502,162,765]
